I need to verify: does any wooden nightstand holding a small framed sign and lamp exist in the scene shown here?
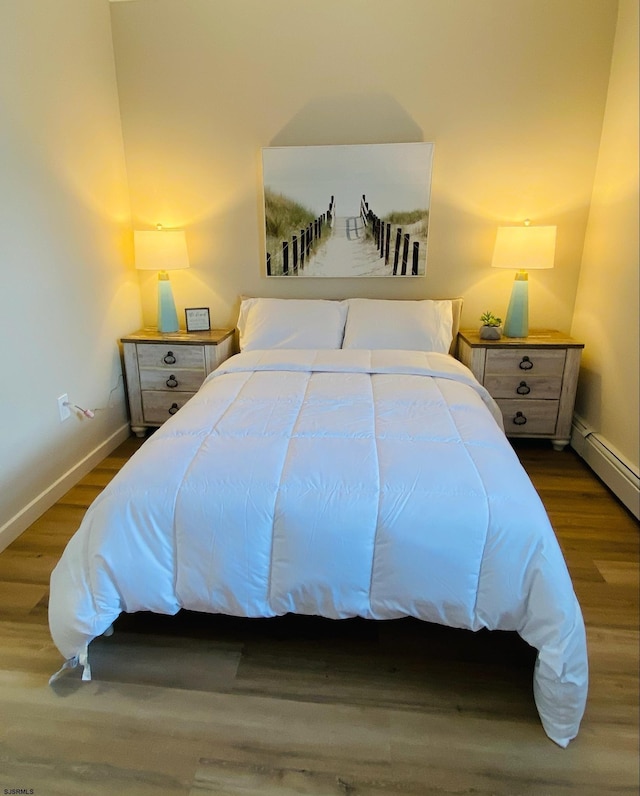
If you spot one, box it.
[121,329,234,437]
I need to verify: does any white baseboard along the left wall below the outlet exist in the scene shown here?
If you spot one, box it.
[0,423,131,552]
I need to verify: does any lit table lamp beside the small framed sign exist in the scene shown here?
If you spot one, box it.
[133,226,189,332]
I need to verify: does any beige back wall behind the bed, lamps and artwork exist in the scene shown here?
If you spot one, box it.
[112,0,616,332]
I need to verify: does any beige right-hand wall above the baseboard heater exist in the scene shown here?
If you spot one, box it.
[572,0,640,472]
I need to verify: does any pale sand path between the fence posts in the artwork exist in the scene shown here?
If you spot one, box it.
[298,216,393,276]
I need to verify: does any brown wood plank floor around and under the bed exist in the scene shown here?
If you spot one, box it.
[0,439,639,796]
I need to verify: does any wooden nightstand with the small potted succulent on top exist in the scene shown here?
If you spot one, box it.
[457,330,584,450]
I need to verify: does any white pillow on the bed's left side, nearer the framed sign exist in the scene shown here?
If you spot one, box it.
[238,298,347,351]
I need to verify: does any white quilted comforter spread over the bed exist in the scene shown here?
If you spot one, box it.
[49,350,587,746]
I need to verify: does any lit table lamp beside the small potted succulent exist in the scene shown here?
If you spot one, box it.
[491,221,556,337]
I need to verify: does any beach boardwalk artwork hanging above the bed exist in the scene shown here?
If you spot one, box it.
[262,143,433,277]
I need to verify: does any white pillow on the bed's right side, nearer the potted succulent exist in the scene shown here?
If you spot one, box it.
[342,299,453,354]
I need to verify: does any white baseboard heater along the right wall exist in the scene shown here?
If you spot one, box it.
[571,415,640,519]
